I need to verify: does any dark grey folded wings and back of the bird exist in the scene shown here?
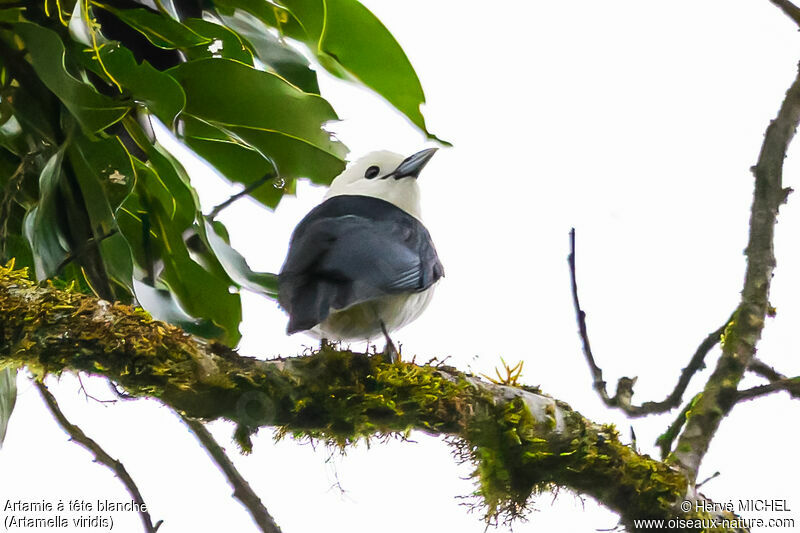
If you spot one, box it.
[279,215,444,333]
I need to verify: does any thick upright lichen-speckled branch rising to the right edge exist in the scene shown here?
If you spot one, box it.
[671,61,800,480]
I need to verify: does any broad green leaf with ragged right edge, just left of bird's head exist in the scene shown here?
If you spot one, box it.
[170,59,346,207]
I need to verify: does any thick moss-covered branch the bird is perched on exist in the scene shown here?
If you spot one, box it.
[0,267,752,524]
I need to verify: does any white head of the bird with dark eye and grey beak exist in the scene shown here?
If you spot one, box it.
[325,148,436,219]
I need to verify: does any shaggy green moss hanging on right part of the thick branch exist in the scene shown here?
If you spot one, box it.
[457,398,687,522]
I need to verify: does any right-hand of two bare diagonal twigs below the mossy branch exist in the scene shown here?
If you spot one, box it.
[180,414,281,533]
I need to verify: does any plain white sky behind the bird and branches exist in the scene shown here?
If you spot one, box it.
[0,0,800,533]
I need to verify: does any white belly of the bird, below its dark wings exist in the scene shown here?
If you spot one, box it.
[309,285,436,341]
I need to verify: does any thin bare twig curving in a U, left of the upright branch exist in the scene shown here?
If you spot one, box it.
[567,228,728,417]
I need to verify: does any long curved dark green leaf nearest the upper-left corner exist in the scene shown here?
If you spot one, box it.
[14,22,130,133]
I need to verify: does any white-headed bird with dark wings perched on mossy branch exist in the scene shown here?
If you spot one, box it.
[278,148,444,362]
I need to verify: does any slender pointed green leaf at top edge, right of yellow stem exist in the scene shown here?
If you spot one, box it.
[94,3,211,49]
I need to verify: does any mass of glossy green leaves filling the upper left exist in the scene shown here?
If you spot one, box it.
[0,0,432,345]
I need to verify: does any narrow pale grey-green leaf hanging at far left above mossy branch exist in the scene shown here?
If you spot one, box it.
[24,148,69,279]
